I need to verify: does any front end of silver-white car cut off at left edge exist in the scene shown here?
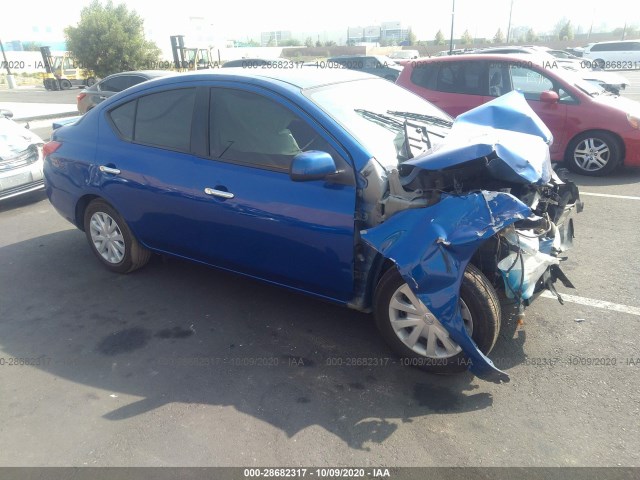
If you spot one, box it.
[0,110,44,201]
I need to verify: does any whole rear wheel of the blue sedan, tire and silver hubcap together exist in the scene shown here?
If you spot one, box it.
[84,199,151,273]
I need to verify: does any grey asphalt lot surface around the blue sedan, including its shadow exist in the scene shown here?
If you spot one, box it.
[0,69,640,467]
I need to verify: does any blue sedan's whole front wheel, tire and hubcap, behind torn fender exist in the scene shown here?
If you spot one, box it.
[374,265,501,373]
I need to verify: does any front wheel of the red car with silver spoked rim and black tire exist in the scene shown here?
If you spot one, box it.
[565,130,622,177]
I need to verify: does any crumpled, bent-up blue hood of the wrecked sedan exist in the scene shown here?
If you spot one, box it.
[403,91,553,185]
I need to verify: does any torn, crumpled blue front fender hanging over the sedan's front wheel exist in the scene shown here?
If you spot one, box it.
[361,191,532,382]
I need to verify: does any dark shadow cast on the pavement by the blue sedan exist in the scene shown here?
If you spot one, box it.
[0,230,522,449]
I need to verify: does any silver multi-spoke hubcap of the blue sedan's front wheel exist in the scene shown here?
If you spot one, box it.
[389,283,473,358]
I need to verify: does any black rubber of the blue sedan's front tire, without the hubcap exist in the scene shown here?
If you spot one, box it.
[374,265,501,374]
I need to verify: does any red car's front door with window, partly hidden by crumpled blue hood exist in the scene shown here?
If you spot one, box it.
[504,63,571,156]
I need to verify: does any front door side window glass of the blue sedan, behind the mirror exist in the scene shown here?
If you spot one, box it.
[209,88,350,173]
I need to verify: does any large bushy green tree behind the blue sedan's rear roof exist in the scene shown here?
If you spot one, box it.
[64,0,160,77]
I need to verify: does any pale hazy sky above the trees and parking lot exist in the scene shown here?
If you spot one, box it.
[0,0,640,42]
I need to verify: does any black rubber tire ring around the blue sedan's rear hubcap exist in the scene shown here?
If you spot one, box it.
[84,199,151,273]
